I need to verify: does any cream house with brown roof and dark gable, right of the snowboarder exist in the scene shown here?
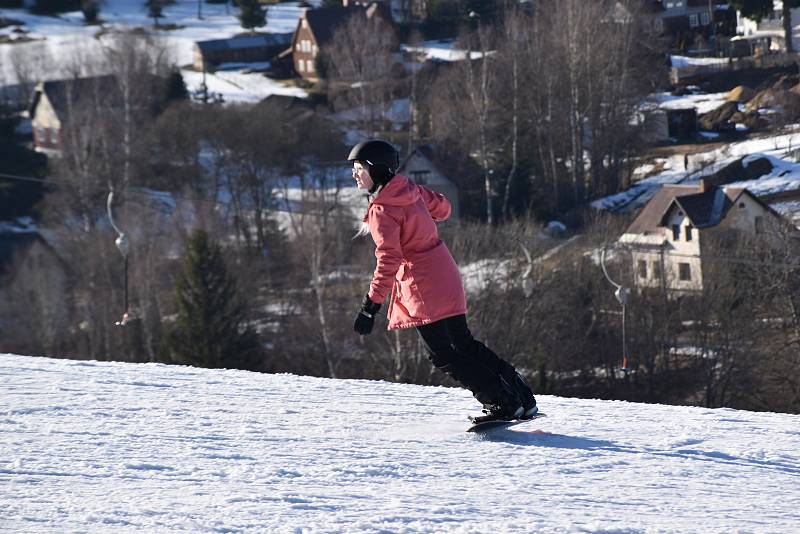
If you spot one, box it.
[619,180,783,294]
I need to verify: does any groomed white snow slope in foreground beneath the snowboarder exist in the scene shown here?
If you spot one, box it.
[0,355,800,532]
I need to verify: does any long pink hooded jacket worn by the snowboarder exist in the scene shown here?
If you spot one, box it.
[364,175,467,330]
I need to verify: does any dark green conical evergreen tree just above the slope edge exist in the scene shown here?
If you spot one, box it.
[168,230,263,371]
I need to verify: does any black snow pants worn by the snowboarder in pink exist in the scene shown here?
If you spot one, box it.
[417,315,530,397]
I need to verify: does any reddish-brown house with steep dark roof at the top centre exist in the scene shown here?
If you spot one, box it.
[291,2,391,82]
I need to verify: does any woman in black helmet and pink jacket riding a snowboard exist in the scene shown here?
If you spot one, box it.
[347,140,538,420]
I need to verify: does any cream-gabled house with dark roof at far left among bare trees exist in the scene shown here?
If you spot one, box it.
[28,76,120,155]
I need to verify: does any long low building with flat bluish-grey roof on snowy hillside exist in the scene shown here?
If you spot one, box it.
[193,33,294,71]
